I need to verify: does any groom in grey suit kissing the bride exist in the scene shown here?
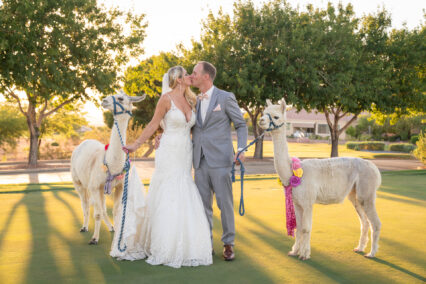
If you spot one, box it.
[191,61,247,261]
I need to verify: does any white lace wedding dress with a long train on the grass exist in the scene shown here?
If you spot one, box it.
[111,100,213,268]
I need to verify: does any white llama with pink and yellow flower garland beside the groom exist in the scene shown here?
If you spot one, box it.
[259,99,381,260]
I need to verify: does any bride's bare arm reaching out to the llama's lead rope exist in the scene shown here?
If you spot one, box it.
[124,96,170,153]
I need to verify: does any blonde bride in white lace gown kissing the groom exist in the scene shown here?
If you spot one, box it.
[111,66,212,268]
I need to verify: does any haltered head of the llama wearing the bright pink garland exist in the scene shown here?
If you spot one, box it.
[259,98,287,130]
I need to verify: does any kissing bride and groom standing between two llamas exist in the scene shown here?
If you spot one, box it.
[110,61,247,268]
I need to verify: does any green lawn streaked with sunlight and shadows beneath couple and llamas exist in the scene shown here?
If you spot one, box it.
[0,170,426,283]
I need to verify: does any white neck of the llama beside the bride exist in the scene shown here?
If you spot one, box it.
[105,115,129,174]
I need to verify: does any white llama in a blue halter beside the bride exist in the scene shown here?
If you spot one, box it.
[71,91,145,244]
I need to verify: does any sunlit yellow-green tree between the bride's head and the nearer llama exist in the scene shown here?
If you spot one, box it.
[122,52,179,157]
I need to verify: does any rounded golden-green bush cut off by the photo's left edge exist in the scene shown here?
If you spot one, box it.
[0,103,26,147]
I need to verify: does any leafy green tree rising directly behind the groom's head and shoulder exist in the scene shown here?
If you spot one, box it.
[183,1,295,158]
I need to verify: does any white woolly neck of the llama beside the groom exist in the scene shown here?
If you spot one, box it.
[271,126,293,185]
